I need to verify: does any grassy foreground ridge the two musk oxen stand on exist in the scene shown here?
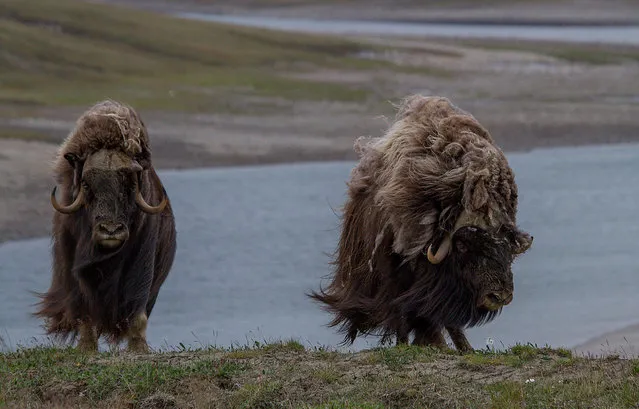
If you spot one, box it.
[0,341,639,409]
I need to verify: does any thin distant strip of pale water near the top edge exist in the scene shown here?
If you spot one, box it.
[176,13,639,45]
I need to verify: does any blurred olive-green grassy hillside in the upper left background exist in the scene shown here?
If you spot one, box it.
[0,0,396,110]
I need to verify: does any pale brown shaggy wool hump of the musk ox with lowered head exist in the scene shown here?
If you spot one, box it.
[350,95,517,258]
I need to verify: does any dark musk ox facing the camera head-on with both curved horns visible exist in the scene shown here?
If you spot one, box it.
[35,100,176,352]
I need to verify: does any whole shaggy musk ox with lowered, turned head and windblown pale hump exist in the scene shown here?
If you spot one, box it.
[309,96,533,351]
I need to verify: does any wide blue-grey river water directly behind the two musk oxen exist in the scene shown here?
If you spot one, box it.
[0,145,639,349]
